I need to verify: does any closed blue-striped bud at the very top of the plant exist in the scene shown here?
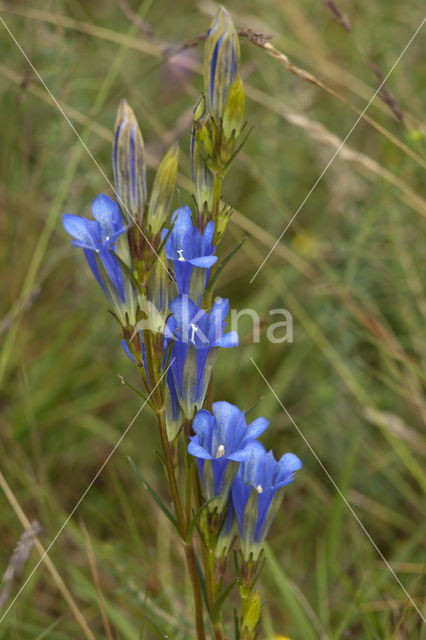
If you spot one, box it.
[203,7,240,119]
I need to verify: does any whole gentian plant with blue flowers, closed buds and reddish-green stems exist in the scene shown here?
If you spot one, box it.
[63,8,301,640]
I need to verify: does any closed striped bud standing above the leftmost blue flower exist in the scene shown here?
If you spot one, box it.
[113,100,147,224]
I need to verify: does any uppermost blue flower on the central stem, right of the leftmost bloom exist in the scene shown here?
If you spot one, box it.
[163,207,217,304]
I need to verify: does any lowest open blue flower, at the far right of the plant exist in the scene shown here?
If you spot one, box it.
[232,445,302,560]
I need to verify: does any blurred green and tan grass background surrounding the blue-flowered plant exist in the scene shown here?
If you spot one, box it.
[0,0,426,640]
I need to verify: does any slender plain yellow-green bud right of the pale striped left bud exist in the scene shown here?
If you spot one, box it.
[148,143,179,233]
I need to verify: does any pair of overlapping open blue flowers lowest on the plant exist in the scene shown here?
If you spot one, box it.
[188,402,302,561]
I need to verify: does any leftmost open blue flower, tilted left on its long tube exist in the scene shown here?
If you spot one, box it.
[62,193,135,324]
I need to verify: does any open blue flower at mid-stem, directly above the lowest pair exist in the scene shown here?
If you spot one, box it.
[169,295,238,418]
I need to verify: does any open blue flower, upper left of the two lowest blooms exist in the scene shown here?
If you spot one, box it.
[188,402,269,511]
